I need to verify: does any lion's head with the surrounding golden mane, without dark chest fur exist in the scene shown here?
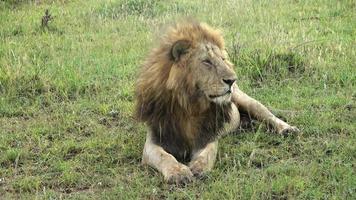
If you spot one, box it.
[136,22,236,121]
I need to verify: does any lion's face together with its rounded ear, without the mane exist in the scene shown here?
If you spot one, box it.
[174,40,236,104]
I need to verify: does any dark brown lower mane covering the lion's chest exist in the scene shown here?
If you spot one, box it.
[151,101,231,162]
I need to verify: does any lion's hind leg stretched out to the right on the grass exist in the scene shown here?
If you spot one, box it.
[232,85,299,134]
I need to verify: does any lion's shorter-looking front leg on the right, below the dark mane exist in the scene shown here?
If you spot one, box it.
[189,140,218,176]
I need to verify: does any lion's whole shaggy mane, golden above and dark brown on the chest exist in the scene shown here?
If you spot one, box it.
[136,24,235,160]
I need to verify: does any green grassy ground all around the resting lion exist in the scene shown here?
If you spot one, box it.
[0,0,356,199]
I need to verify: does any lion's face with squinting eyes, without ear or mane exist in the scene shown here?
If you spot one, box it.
[189,43,236,104]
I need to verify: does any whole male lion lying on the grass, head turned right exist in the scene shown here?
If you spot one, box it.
[136,22,298,184]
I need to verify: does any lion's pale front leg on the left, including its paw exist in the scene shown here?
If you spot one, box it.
[142,131,193,184]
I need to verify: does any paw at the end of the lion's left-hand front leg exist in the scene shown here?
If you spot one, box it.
[165,164,194,185]
